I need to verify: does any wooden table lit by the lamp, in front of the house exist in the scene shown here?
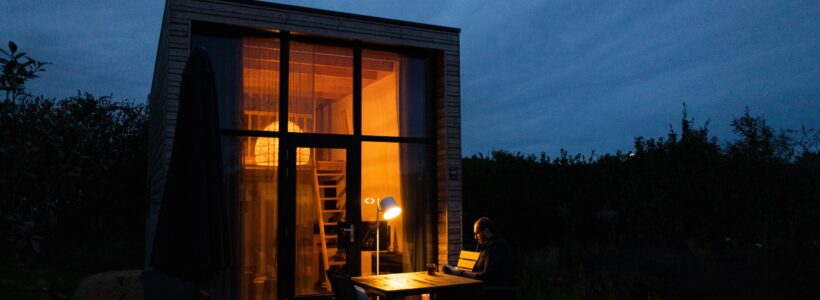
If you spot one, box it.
[352,272,481,300]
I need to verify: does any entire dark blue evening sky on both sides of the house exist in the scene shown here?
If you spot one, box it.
[0,0,820,155]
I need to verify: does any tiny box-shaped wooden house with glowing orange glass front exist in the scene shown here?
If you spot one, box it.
[146,0,463,299]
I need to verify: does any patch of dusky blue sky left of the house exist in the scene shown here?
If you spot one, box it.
[0,0,163,102]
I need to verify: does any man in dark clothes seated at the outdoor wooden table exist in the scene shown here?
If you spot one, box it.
[443,217,513,287]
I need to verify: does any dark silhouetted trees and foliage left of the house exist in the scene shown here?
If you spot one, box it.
[0,42,148,268]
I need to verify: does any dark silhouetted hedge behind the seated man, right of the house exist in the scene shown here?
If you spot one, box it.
[463,107,820,299]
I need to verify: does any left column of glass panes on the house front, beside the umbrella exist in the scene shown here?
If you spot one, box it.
[199,35,280,299]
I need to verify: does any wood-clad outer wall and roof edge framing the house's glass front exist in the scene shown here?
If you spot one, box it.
[146,0,462,266]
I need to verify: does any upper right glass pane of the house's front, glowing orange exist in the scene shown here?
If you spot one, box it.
[362,50,429,137]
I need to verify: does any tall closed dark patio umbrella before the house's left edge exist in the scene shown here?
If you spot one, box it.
[150,49,231,284]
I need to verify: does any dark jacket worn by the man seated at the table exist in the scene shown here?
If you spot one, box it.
[464,237,513,286]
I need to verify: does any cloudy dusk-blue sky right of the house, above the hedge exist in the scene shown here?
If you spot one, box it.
[454,1,820,154]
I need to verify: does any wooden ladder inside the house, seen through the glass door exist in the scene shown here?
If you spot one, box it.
[313,160,347,291]
